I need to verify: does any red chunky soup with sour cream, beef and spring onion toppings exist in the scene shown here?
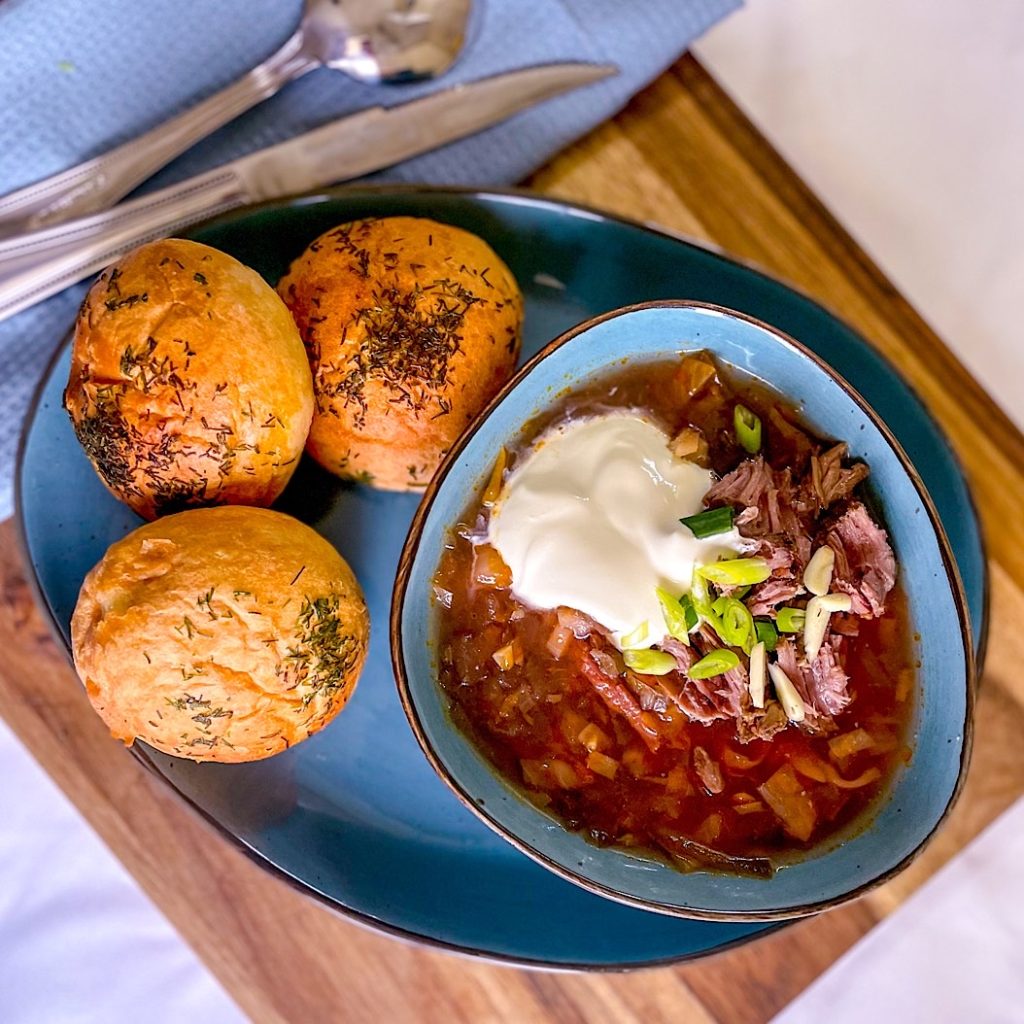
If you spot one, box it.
[434,353,914,874]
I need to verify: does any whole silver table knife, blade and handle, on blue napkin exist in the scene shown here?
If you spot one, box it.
[0,62,617,321]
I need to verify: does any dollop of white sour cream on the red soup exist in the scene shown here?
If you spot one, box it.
[488,411,742,647]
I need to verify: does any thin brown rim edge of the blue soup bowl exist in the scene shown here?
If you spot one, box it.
[388,299,977,922]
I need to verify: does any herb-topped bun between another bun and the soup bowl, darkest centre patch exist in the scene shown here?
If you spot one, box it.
[278,217,522,490]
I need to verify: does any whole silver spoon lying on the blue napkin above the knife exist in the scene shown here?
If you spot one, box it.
[0,0,472,238]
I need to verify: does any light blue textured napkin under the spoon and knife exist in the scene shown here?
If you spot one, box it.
[0,0,740,518]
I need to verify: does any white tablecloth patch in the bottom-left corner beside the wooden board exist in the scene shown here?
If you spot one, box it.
[0,720,246,1024]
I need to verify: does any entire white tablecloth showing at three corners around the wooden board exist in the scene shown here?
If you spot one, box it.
[0,0,1024,1024]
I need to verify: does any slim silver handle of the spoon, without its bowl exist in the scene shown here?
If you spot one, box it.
[0,29,317,238]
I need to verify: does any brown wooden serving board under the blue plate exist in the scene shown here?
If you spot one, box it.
[0,57,1024,1024]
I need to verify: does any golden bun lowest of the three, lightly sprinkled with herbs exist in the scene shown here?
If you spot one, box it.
[72,507,370,761]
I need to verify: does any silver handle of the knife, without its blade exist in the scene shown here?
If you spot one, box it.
[0,167,249,321]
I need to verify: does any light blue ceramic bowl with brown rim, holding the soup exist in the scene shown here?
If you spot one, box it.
[391,302,975,921]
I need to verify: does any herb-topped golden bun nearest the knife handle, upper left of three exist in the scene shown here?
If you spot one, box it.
[65,239,313,519]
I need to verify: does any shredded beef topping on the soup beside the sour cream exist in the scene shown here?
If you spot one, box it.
[606,413,896,741]
